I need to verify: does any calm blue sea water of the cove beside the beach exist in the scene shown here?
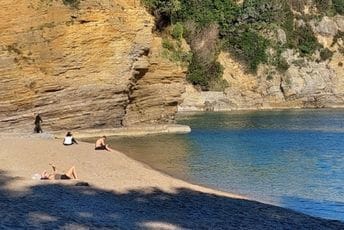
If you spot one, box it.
[110,110,344,221]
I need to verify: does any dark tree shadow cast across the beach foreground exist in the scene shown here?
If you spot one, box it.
[0,171,344,229]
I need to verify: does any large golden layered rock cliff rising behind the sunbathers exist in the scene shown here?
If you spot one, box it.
[0,0,185,131]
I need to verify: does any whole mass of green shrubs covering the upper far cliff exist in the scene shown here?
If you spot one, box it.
[142,0,344,90]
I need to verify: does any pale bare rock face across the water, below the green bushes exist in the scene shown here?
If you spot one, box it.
[179,15,344,111]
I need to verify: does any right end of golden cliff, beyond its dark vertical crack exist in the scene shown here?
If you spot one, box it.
[123,36,186,125]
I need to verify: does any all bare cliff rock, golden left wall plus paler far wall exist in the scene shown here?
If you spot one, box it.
[0,0,344,132]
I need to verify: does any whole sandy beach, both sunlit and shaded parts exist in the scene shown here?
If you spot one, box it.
[0,135,344,229]
